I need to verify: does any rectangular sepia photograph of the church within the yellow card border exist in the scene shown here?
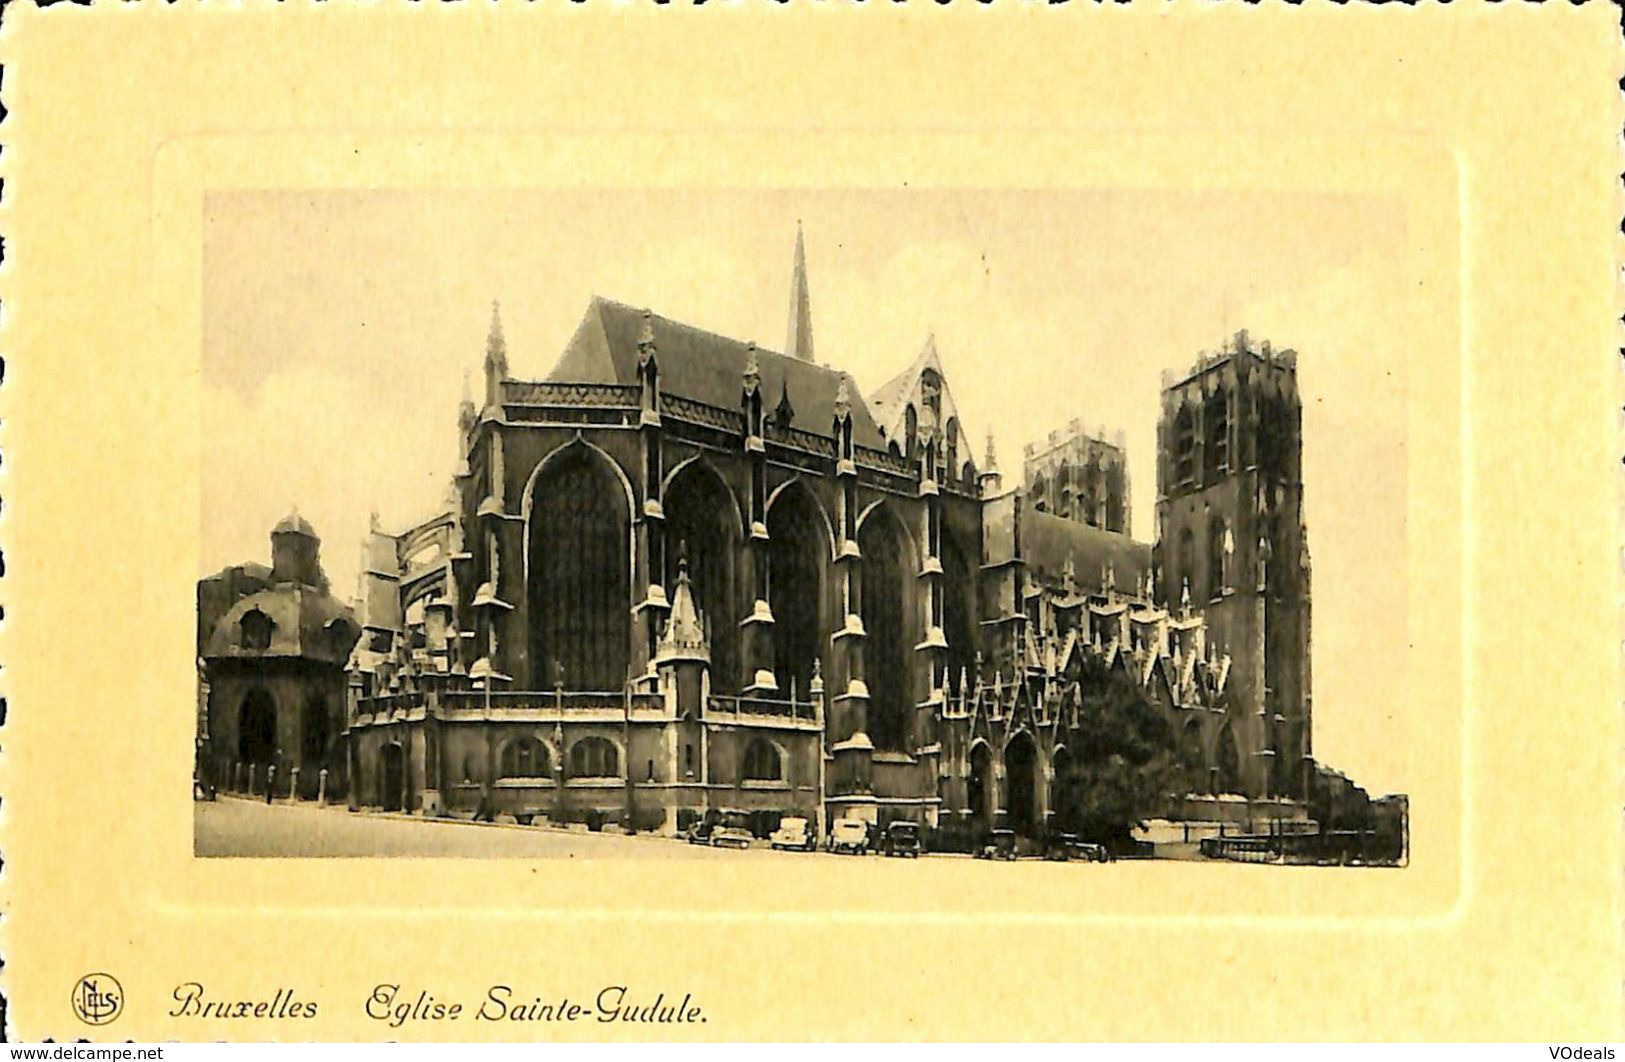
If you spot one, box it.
[195,190,1417,867]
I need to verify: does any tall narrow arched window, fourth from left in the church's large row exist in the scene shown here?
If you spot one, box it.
[858,508,913,752]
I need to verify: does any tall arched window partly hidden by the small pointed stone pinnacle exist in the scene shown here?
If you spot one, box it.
[665,461,739,695]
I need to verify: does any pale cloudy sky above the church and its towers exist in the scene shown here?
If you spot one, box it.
[198,188,1425,794]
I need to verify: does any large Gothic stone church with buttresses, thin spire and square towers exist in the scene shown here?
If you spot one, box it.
[343,235,1332,844]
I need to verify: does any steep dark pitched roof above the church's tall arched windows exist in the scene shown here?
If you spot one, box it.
[548,296,886,450]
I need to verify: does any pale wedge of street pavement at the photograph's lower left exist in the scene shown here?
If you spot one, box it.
[192,796,830,859]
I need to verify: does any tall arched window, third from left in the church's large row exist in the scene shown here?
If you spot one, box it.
[767,484,829,698]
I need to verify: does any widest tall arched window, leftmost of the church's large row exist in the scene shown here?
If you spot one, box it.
[530,447,632,692]
